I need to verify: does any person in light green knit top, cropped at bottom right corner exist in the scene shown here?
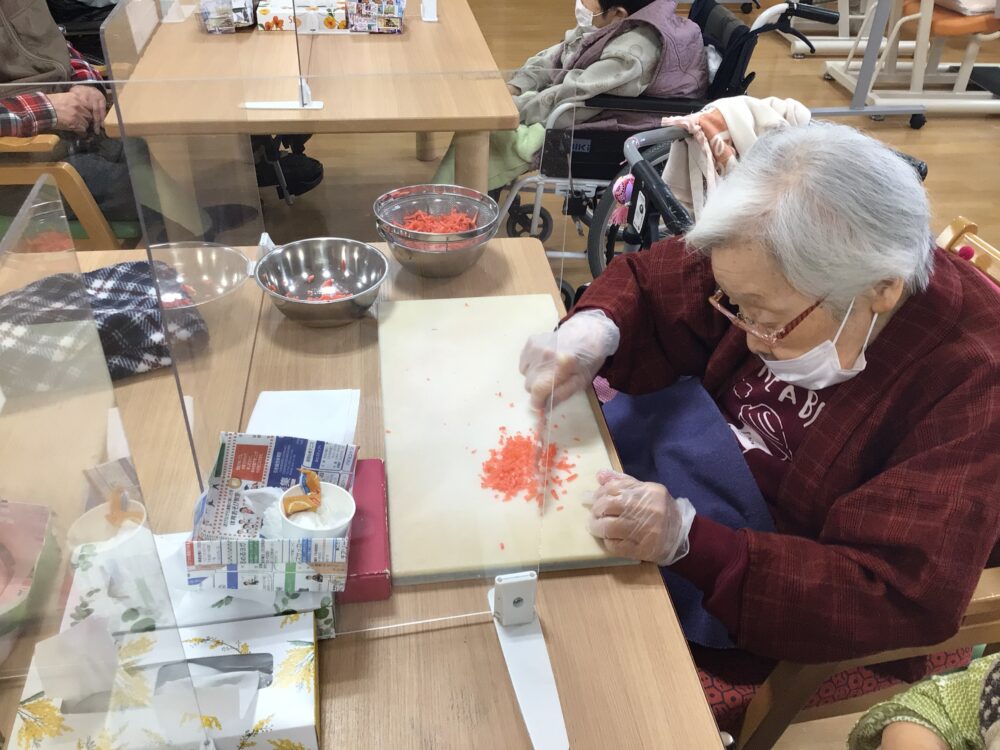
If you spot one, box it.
[847,655,1000,750]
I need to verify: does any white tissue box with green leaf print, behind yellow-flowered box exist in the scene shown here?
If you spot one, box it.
[61,529,336,638]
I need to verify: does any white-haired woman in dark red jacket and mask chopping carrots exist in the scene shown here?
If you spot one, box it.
[521,124,1000,712]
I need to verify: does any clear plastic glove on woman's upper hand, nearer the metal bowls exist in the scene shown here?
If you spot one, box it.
[520,310,620,409]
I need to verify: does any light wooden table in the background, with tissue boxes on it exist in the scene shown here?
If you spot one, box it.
[105,0,518,189]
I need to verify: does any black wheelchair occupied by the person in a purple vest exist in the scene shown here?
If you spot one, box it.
[491,0,839,308]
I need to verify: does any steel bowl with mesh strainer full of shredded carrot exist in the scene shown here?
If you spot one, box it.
[373,185,500,277]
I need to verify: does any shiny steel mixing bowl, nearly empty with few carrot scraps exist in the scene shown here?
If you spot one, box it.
[254,237,389,327]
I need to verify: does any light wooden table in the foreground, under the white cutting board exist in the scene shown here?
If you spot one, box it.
[0,239,720,750]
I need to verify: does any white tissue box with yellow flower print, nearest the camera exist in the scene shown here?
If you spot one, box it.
[12,614,319,750]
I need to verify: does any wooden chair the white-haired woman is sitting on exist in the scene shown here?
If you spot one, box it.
[737,216,1000,750]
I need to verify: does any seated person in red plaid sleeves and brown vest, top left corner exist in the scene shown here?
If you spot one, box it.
[0,0,257,242]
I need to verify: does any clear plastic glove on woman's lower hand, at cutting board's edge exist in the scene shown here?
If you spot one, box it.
[587,470,695,565]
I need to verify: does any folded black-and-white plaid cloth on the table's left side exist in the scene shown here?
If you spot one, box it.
[0,262,208,396]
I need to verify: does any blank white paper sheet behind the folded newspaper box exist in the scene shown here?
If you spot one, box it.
[246,390,361,445]
